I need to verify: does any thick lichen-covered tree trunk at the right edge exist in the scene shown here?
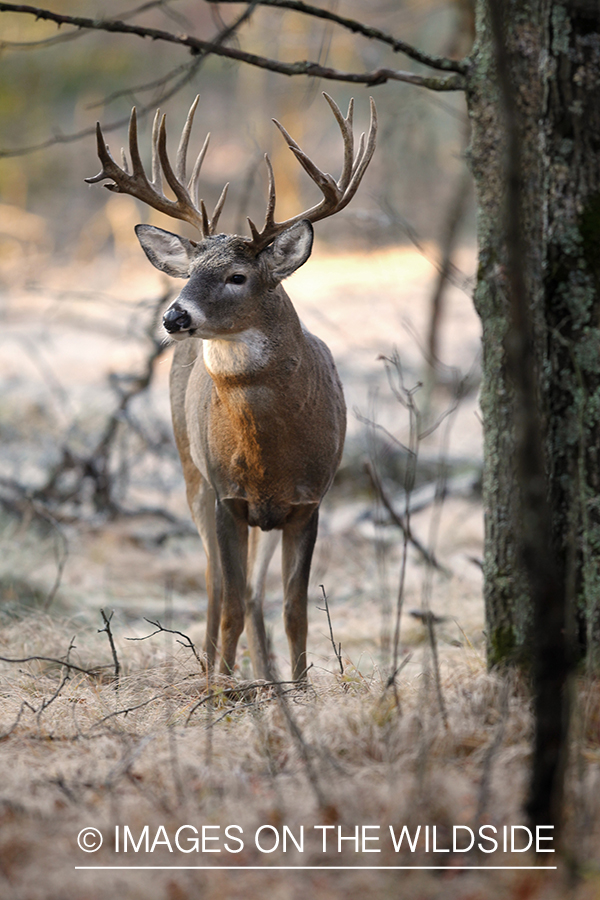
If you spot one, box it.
[468,0,600,668]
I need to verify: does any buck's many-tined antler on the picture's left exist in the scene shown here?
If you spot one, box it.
[85,97,229,237]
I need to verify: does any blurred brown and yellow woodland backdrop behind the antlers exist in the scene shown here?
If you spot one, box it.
[0,0,473,260]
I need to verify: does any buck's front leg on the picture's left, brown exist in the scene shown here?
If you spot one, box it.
[215,500,248,675]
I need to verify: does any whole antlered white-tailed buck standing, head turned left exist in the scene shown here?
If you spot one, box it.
[86,94,377,680]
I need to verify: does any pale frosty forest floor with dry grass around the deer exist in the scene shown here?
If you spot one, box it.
[0,241,600,900]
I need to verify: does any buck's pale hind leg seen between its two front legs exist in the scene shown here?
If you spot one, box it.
[245,528,279,681]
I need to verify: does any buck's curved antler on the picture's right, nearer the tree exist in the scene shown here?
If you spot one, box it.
[248,92,377,252]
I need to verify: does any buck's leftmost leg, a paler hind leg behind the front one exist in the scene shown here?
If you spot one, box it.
[188,472,223,669]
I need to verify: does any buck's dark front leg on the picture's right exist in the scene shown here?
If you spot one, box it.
[282,504,319,681]
